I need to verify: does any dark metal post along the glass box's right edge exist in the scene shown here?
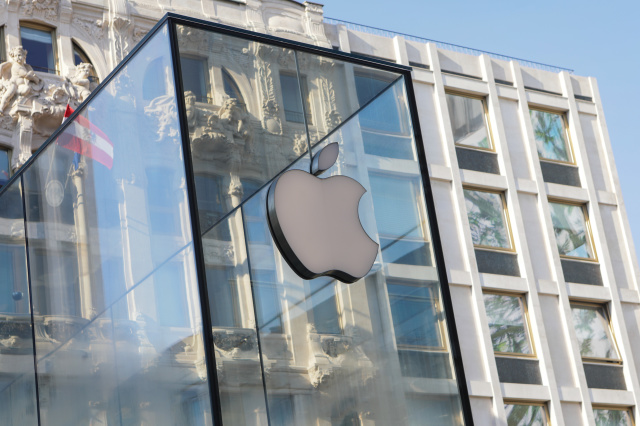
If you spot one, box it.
[404,71,473,426]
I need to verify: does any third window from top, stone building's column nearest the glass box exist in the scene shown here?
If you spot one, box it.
[484,293,534,355]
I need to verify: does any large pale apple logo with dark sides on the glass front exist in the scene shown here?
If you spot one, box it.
[267,142,378,283]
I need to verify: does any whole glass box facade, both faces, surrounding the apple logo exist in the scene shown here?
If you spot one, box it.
[0,18,468,426]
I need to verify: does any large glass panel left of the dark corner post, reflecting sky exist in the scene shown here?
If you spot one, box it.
[23,26,211,425]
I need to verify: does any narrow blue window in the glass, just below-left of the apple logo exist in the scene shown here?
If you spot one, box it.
[251,269,284,333]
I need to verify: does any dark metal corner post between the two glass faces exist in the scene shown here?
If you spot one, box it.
[168,19,222,426]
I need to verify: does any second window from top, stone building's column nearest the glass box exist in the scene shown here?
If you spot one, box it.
[464,189,513,250]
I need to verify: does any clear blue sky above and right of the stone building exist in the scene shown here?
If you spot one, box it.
[317,0,640,260]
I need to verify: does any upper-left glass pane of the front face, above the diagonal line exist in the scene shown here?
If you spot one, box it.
[177,26,308,234]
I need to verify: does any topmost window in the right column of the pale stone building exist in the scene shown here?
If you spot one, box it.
[529,109,573,163]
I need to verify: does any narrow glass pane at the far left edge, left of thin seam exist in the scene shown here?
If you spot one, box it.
[0,181,38,426]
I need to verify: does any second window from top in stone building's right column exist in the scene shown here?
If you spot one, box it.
[549,202,596,260]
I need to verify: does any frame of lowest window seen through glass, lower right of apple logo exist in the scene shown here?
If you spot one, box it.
[384,277,450,353]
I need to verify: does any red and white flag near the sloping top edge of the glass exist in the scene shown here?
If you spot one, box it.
[58,105,113,169]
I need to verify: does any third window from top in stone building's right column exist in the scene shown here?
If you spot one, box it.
[571,305,620,359]
